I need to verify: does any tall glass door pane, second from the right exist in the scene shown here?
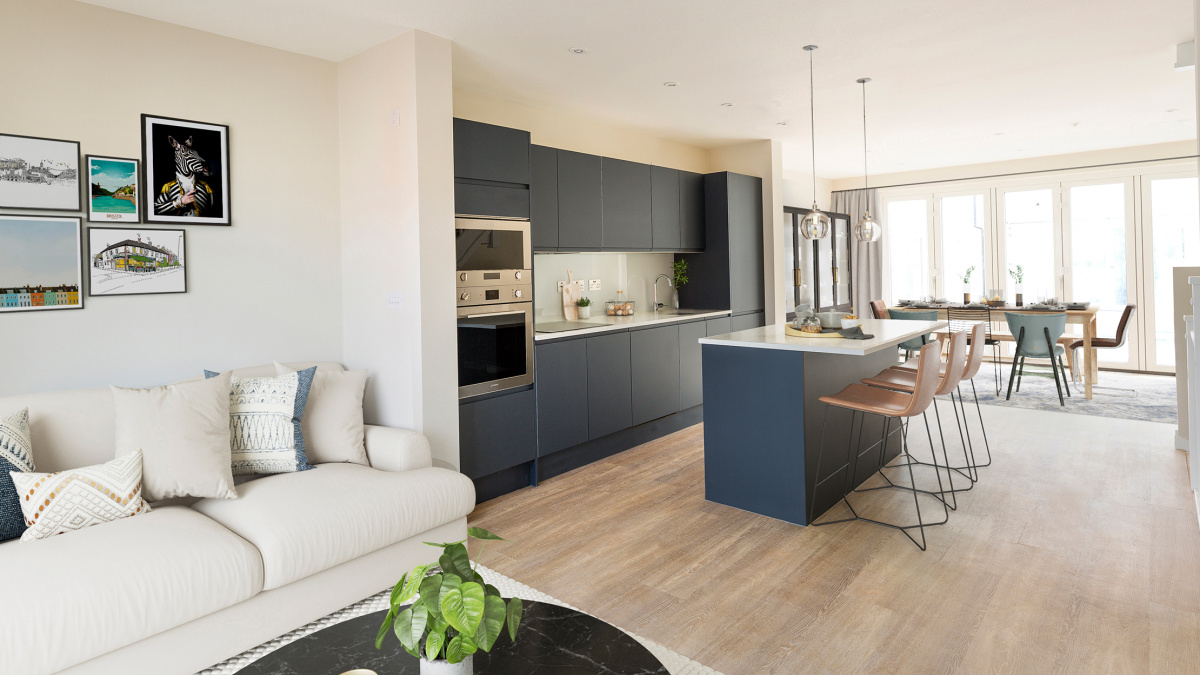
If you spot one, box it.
[1066,183,1129,363]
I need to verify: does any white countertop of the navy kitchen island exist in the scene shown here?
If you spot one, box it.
[700,318,947,356]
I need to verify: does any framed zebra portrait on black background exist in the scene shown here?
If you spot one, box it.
[142,115,229,225]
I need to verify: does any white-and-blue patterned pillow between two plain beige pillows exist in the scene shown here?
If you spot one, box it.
[204,366,317,476]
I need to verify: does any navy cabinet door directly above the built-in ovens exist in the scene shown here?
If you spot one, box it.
[454,118,529,185]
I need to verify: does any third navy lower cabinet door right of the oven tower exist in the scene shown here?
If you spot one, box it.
[629,324,679,425]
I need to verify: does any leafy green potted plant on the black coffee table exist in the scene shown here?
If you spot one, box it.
[376,527,523,675]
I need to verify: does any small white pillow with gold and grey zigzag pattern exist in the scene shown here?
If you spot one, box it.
[10,450,150,542]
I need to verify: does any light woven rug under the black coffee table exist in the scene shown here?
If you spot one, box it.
[198,566,721,675]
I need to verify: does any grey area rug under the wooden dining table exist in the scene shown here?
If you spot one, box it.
[966,363,1178,424]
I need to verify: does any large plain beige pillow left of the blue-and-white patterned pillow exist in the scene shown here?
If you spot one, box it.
[112,372,238,502]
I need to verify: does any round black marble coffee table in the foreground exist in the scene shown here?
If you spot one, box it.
[236,602,667,675]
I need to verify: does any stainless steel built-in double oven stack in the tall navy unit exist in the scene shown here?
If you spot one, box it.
[455,219,533,399]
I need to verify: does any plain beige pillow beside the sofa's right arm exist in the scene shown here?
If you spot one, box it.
[275,362,370,466]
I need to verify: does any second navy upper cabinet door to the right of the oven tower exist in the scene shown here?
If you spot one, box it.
[558,150,604,251]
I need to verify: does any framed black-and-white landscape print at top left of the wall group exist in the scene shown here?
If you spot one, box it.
[0,133,82,211]
